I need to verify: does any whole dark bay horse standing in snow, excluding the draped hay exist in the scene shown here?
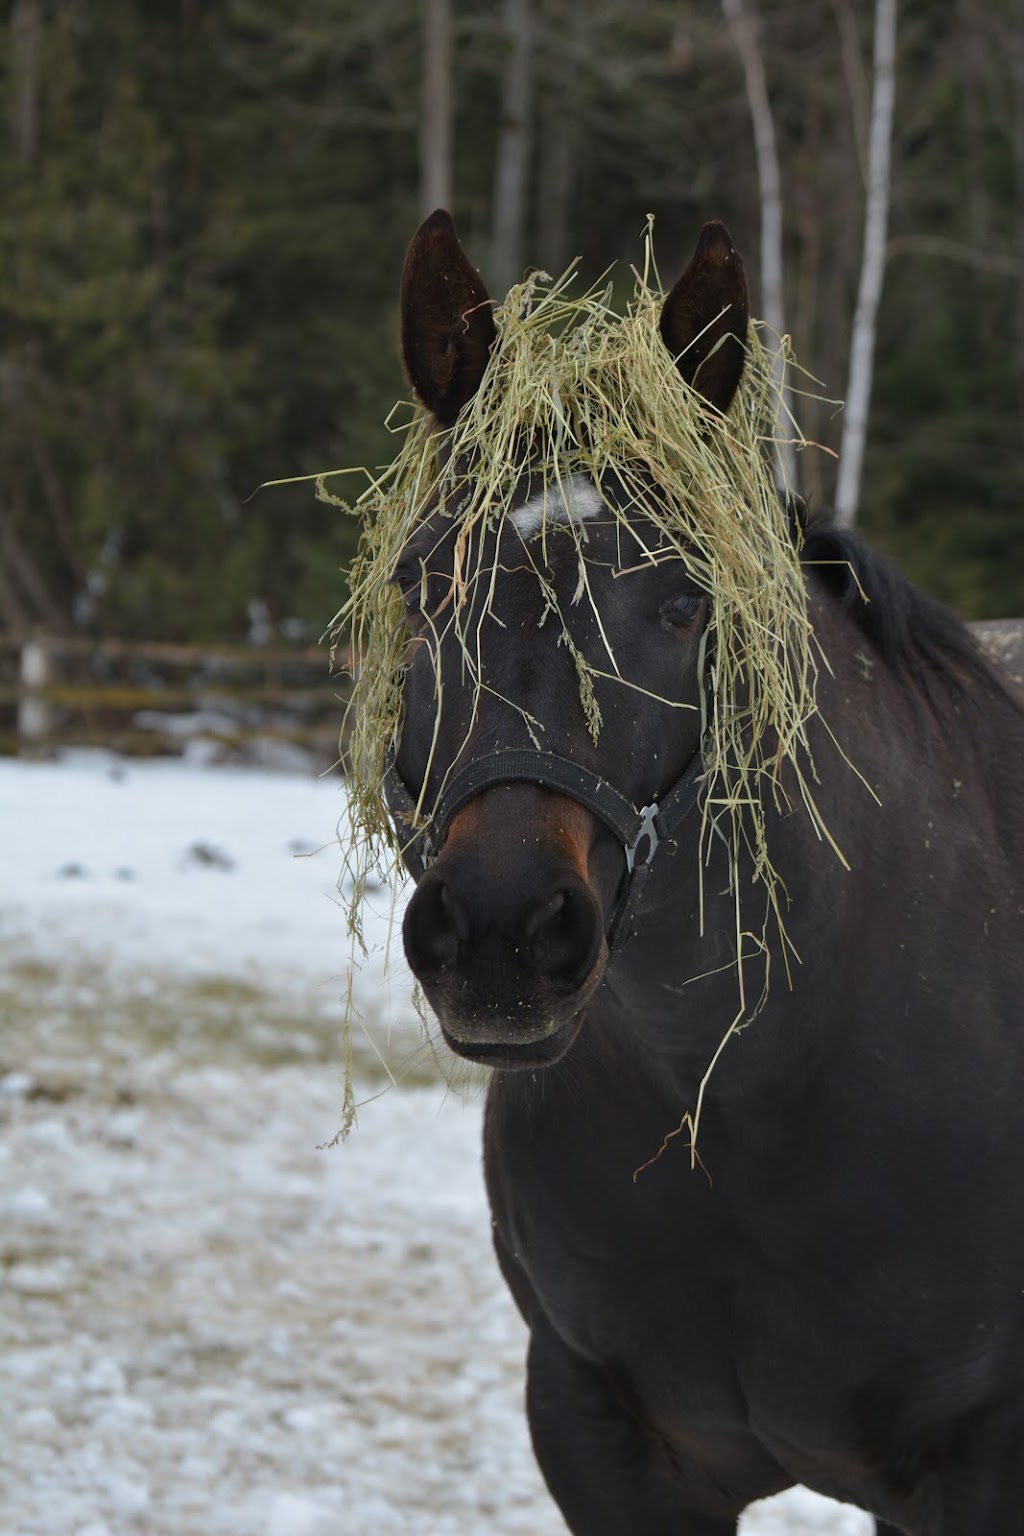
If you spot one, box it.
[380,214,1024,1536]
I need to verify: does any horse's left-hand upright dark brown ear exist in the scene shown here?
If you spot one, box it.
[402,209,494,427]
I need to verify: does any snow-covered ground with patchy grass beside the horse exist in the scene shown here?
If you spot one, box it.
[0,754,872,1536]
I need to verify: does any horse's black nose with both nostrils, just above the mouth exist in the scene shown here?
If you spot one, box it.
[402,860,603,995]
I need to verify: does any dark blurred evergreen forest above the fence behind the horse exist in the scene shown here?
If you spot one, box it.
[0,0,1024,641]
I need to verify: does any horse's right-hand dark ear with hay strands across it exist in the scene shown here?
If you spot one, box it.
[662,220,751,413]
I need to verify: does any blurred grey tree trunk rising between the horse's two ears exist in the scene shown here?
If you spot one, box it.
[490,0,533,295]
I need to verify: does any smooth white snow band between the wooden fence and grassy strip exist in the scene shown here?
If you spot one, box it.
[0,753,408,997]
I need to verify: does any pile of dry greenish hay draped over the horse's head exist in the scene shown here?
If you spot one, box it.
[327,230,827,1142]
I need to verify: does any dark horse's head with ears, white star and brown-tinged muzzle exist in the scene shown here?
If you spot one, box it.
[383,214,748,1068]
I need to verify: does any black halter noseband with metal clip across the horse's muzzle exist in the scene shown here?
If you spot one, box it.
[384,748,703,949]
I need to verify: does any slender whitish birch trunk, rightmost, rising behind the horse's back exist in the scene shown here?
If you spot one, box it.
[835,0,897,528]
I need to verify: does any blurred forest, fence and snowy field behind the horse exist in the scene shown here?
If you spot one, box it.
[0,12,1024,1536]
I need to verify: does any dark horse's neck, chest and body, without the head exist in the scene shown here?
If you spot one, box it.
[487,571,1024,1536]
